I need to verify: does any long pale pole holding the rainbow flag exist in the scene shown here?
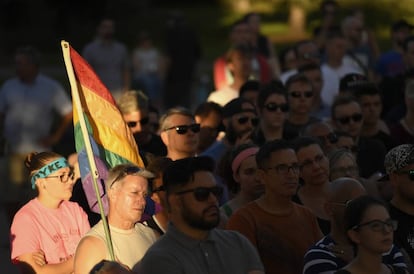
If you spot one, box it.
[61,40,115,261]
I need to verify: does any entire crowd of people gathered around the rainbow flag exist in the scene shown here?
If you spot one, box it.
[0,0,414,274]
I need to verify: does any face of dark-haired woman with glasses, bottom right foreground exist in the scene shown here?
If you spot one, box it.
[348,205,394,255]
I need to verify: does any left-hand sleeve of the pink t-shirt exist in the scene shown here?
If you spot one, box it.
[10,212,40,260]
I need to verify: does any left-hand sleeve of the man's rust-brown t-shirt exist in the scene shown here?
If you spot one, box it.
[226,210,257,247]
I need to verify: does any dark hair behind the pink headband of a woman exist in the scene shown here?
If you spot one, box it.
[218,143,257,194]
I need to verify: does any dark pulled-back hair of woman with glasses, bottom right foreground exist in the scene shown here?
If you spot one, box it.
[344,195,387,231]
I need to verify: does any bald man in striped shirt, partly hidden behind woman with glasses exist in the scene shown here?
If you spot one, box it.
[303,177,406,274]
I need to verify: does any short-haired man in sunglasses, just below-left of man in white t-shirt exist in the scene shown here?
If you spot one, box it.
[284,73,320,137]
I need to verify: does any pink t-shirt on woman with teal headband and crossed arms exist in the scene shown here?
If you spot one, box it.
[10,198,90,264]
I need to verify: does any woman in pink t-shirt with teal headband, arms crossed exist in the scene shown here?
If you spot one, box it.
[10,152,90,274]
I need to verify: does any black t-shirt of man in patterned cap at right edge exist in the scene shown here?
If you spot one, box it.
[389,203,414,262]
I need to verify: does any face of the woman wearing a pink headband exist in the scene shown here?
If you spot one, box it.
[234,155,264,199]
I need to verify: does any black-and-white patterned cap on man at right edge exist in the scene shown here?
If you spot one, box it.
[384,144,414,174]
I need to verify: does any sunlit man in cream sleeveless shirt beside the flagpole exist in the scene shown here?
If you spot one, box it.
[74,164,157,274]
